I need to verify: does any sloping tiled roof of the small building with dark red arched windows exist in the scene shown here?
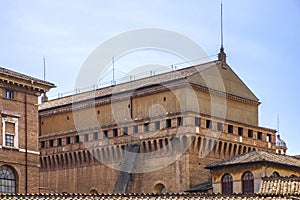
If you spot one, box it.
[206,151,300,169]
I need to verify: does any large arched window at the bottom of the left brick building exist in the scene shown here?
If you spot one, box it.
[0,165,16,194]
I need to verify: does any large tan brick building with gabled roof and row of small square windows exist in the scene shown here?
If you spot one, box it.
[39,49,276,193]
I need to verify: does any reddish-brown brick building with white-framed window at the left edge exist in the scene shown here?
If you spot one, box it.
[0,68,54,193]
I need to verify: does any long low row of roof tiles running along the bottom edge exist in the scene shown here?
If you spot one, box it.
[0,193,299,200]
